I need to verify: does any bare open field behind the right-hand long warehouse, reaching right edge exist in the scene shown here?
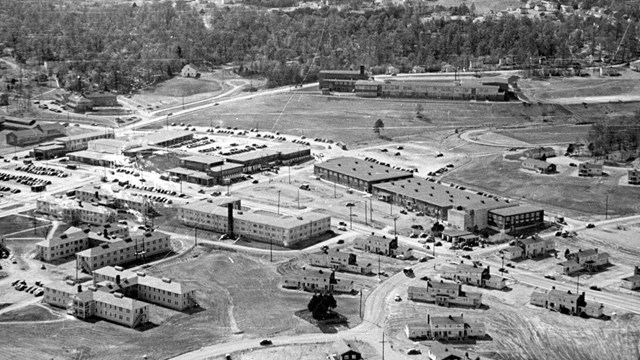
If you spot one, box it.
[444,155,640,218]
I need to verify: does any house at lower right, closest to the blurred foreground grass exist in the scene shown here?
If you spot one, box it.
[530,286,604,318]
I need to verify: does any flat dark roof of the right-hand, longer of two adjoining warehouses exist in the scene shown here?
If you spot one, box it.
[374,177,514,209]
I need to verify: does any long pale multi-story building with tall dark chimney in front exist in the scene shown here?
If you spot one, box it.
[178,198,331,247]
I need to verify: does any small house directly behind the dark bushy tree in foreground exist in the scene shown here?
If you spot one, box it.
[282,270,353,292]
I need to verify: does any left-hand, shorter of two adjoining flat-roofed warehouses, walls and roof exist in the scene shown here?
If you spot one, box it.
[313,157,413,192]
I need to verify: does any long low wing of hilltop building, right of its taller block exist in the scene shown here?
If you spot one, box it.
[355,80,506,101]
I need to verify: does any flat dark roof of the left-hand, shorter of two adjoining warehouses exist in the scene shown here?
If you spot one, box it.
[314,157,416,182]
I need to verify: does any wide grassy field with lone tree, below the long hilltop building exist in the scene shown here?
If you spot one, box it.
[172,92,572,145]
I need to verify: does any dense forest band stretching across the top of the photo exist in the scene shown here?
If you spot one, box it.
[0,0,640,92]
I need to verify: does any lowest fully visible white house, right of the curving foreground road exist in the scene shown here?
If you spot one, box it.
[405,314,486,340]
